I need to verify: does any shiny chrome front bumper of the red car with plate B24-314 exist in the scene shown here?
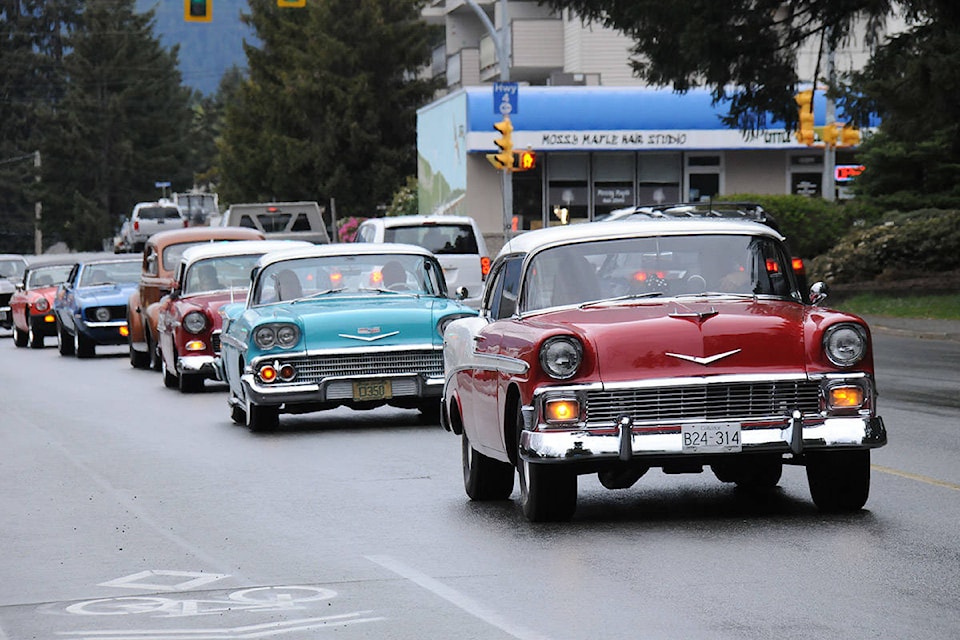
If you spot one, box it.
[520,407,887,462]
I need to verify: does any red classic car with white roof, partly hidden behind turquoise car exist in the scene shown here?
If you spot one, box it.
[157,240,313,393]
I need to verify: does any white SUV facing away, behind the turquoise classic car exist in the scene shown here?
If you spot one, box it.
[354,216,490,308]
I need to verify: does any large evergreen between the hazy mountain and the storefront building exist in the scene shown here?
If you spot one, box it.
[220,0,436,216]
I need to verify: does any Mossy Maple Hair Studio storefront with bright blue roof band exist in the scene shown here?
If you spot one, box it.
[417,85,868,246]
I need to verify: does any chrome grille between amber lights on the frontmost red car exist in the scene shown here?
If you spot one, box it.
[587,380,820,426]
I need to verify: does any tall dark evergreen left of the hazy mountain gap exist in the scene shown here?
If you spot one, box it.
[44,0,193,250]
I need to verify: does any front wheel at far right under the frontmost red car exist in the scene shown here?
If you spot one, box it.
[806,450,870,512]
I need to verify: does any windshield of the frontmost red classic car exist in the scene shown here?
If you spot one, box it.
[521,234,800,311]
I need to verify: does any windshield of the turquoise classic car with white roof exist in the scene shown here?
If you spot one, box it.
[252,253,446,305]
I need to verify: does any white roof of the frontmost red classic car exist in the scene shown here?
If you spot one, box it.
[499,218,783,255]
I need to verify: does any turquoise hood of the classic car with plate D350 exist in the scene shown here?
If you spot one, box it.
[247,295,476,349]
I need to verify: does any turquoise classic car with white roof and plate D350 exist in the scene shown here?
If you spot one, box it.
[220,244,476,431]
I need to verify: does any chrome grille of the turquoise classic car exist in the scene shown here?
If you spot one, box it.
[283,350,443,382]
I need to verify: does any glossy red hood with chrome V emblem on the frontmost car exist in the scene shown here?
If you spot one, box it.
[536,299,809,382]
